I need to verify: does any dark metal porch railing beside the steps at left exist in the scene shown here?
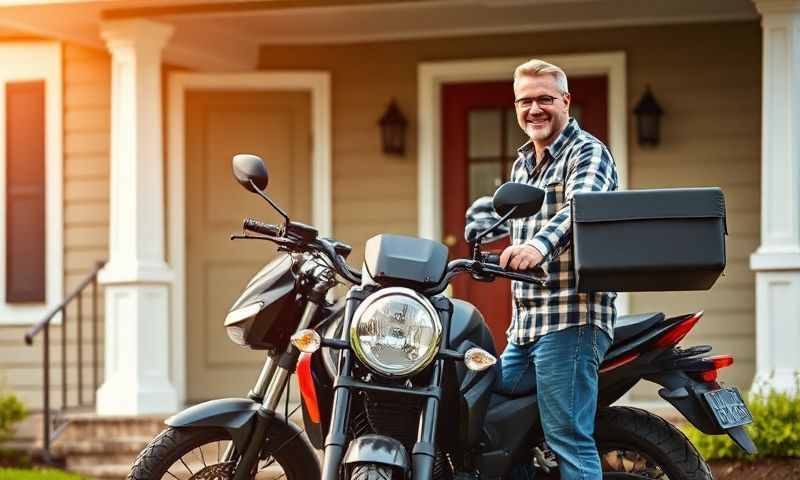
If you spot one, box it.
[25,261,106,460]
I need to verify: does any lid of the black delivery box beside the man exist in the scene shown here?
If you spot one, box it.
[572,187,727,225]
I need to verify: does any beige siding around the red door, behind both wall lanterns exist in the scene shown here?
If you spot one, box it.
[261,22,761,399]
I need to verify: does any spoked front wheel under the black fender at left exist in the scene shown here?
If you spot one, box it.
[128,427,320,480]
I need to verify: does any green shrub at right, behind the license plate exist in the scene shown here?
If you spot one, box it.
[683,392,800,460]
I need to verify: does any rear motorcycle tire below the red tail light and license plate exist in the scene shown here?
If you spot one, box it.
[595,407,714,480]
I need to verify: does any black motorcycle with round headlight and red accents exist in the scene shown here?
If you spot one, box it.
[128,154,756,480]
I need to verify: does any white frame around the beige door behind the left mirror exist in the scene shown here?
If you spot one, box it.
[167,70,333,404]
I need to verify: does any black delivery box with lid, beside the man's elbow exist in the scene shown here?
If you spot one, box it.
[572,188,727,292]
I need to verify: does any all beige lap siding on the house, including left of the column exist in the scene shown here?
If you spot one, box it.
[0,22,761,409]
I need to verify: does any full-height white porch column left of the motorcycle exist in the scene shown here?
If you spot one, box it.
[97,19,179,415]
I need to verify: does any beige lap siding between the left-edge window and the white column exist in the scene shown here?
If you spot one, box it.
[0,45,111,410]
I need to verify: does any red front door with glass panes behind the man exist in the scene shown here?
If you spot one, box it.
[442,76,608,352]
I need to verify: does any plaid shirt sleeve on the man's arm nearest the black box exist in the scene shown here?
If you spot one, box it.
[527,142,618,261]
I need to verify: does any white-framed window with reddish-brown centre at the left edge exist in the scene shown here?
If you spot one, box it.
[0,42,63,324]
